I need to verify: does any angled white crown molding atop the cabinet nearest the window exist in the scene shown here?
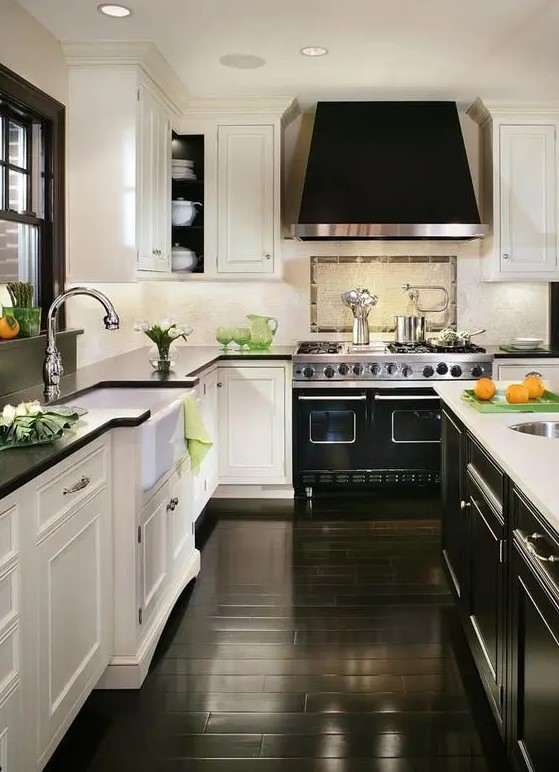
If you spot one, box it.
[62,41,189,114]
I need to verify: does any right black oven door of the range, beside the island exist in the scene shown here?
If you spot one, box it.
[369,388,441,485]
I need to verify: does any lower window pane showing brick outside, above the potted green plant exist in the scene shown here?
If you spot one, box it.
[0,220,39,292]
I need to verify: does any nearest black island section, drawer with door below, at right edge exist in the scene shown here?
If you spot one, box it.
[509,490,559,772]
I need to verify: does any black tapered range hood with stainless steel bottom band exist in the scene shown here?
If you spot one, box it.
[291,102,486,241]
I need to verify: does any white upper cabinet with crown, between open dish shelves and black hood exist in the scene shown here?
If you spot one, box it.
[176,99,296,279]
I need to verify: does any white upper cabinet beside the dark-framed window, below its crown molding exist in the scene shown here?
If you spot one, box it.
[67,60,171,283]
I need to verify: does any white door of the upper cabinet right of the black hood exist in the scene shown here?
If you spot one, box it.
[500,125,557,274]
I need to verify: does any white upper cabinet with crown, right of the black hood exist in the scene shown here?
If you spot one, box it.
[469,100,559,281]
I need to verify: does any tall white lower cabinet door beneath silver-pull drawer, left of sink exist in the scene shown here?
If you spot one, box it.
[37,489,112,759]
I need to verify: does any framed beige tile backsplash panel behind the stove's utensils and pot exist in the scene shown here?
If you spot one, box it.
[310,255,456,332]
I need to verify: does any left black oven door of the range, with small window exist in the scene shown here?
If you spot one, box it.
[293,387,372,489]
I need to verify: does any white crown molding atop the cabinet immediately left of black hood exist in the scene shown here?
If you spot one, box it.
[184,96,300,125]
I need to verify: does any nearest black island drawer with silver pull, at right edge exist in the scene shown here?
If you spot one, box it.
[512,488,559,601]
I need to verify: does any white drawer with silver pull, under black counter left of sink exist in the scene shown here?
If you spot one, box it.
[37,442,110,538]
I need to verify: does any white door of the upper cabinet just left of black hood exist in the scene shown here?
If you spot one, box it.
[217,126,276,273]
